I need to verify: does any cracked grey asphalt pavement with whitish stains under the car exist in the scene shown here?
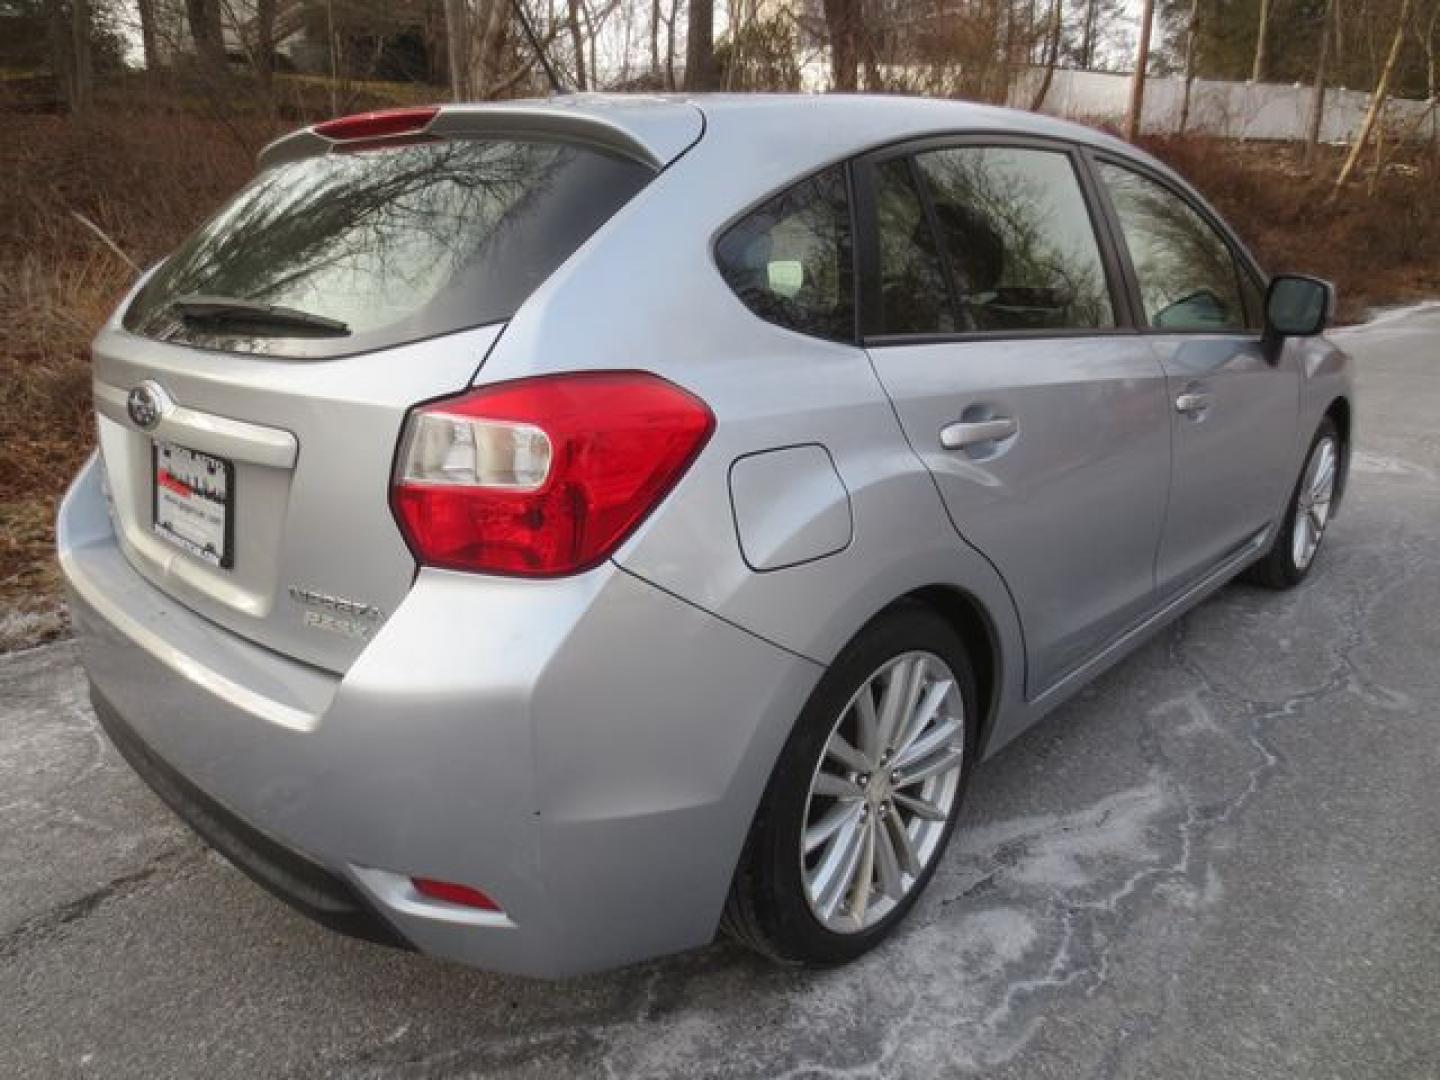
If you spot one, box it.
[0,304,1440,1080]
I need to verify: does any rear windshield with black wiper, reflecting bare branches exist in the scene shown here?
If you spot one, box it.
[124,140,652,357]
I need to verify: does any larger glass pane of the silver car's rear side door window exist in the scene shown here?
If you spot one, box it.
[916,147,1115,330]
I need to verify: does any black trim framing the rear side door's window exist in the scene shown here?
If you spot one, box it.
[851,131,1138,347]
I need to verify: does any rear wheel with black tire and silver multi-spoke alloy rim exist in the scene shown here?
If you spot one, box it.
[721,605,979,965]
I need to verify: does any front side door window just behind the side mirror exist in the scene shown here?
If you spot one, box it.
[1100,161,1246,330]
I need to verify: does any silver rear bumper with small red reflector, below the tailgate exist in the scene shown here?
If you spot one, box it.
[58,462,819,976]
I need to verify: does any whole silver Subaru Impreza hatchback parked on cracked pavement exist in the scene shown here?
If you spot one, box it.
[59,96,1352,976]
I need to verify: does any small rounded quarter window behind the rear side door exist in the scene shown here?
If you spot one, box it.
[716,167,855,341]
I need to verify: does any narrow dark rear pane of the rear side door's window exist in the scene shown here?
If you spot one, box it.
[876,158,956,334]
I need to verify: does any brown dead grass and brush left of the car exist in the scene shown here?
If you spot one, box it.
[0,109,278,649]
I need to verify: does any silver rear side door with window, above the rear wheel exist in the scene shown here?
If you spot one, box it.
[857,141,1171,696]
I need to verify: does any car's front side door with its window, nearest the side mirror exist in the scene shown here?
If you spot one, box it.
[1096,160,1300,593]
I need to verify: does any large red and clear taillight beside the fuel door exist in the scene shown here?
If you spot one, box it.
[390,372,714,577]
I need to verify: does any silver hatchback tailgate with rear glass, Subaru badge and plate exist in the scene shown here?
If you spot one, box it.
[94,126,655,671]
